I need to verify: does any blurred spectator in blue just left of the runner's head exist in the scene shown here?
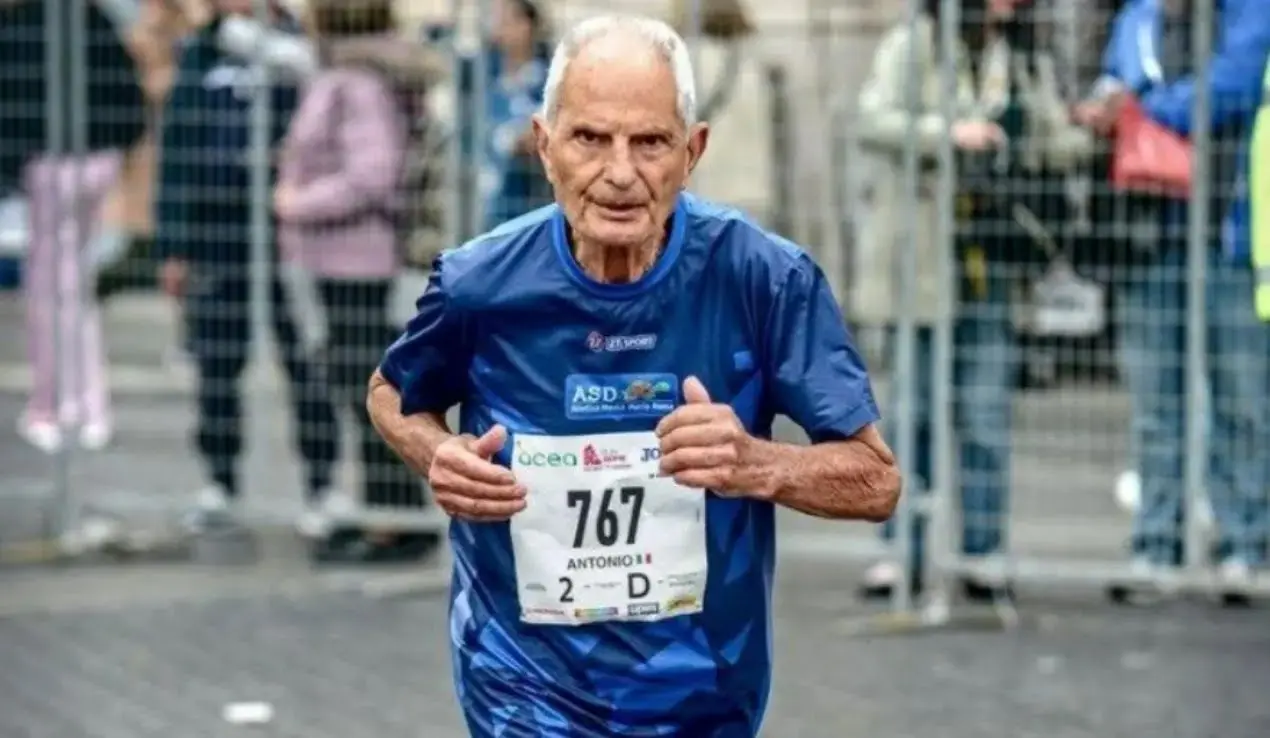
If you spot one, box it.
[428,0,552,231]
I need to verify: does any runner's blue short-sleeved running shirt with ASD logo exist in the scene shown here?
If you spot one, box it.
[381,194,878,738]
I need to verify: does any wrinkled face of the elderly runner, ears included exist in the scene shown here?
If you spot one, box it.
[533,38,709,248]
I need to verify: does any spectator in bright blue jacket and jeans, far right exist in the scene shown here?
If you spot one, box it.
[1077,0,1270,602]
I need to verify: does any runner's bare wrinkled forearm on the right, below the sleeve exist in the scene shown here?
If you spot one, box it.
[734,431,900,522]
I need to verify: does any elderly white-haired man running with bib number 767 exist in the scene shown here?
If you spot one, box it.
[368,12,900,738]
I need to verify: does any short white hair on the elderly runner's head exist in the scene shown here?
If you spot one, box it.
[542,15,697,126]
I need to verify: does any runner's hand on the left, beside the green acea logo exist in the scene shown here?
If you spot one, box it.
[428,426,526,522]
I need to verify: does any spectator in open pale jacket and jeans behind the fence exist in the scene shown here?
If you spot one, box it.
[853,0,1088,598]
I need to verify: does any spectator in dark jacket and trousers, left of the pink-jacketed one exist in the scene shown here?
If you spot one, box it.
[155,0,338,527]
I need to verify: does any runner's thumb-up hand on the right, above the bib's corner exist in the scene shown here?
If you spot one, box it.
[657,377,752,494]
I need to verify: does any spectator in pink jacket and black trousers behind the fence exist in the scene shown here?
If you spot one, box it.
[274,0,441,561]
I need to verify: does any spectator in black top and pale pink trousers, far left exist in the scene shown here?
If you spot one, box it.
[0,0,145,452]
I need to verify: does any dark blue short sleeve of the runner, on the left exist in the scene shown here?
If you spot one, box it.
[380,259,471,415]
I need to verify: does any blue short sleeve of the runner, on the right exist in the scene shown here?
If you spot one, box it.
[765,259,879,443]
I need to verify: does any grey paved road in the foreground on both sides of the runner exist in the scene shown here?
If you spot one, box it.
[0,564,1270,738]
